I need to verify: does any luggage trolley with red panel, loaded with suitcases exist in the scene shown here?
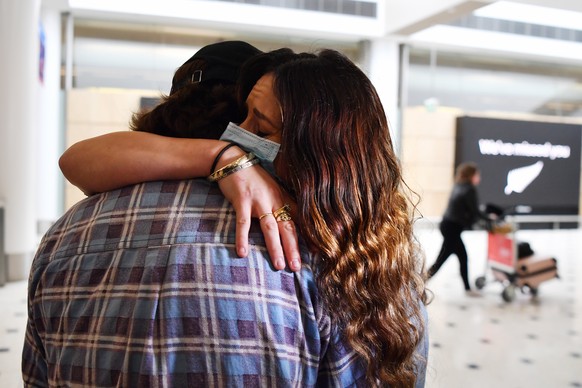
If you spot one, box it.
[475,218,558,302]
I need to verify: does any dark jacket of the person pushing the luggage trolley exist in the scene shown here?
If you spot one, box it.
[443,183,488,229]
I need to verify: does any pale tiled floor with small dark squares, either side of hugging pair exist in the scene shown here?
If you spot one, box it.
[0,227,582,388]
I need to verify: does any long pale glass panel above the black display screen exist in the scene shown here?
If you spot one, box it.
[408,48,582,117]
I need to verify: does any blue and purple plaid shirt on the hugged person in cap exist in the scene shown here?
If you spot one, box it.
[22,180,364,387]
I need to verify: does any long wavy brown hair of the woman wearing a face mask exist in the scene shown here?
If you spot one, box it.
[275,50,426,387]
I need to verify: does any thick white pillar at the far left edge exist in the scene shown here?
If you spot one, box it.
[0,0,40,280]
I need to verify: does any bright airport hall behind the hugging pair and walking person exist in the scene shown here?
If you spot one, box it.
[0,0,582,388]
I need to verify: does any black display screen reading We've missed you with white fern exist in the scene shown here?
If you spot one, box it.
[455,117,582,215]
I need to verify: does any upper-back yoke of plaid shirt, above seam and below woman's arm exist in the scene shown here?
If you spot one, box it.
[37,179,231,257]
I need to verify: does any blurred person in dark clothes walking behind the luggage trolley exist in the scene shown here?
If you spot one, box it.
[428,162,488,296]
